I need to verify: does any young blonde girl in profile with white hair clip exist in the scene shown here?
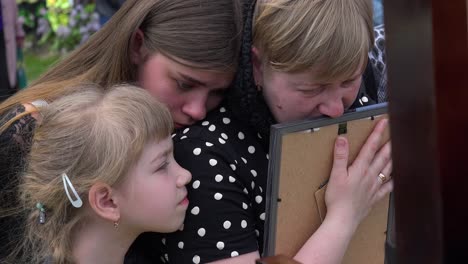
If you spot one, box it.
[4,85,191,264]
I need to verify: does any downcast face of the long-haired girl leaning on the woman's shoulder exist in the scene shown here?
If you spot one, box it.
[138,53,234,128]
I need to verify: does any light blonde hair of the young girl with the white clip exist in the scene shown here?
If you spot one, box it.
[4,85,173,264]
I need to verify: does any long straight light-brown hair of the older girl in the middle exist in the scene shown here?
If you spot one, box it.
[0,0,242,127]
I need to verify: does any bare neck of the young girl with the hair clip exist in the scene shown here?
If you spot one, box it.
[73,221,138,264]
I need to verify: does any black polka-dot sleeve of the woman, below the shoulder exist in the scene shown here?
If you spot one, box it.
[164,132,259,263]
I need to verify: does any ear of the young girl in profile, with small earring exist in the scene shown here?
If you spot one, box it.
[88,182,120,222]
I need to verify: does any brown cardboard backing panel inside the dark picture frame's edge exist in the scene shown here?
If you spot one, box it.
[275,116,389,264]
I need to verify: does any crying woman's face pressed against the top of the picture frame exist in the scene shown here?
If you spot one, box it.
[256,64,362,122]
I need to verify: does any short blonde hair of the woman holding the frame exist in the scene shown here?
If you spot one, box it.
[253,0,374,81]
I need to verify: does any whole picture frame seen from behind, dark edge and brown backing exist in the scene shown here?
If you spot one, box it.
[264,104,389,264]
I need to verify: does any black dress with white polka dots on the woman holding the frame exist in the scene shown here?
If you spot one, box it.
[161,107,268,263]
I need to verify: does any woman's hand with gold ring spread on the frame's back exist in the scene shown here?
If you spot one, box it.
[325,119,393,228]
